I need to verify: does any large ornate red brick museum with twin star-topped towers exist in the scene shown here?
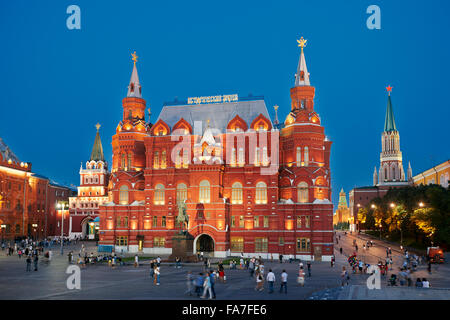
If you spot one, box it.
[100,39,333,260]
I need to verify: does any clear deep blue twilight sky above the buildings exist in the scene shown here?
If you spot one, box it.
[0,0,450,208]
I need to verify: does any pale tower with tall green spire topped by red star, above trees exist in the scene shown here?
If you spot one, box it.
[373,86,407,185]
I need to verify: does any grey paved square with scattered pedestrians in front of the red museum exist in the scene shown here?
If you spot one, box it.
[0,234,450,300]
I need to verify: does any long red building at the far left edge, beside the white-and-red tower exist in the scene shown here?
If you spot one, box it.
[0,138,72,239]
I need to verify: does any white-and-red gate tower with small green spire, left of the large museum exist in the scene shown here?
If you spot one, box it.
[68,124,109,239]
